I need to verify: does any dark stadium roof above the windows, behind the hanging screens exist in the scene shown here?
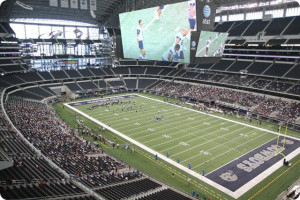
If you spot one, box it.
[1,0,299,28]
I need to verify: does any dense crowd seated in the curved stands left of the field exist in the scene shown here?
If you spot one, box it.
[7,97,140,186]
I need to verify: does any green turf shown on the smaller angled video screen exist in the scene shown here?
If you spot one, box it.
[196,31,227,57]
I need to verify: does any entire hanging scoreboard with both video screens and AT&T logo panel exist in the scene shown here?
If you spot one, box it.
[117,0,227,64]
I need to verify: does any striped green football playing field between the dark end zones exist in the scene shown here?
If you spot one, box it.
[75,94,276,174]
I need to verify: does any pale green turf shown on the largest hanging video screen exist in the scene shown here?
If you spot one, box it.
[120,1,190,63]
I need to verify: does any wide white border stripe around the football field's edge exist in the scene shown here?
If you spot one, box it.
[64,94,300,199]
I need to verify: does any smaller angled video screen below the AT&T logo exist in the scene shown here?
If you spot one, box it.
[196,31,228,57]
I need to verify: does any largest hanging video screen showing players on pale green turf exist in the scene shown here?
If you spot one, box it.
[119,0,197,63]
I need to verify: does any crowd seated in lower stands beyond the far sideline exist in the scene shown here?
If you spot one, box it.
[153,82,300,121]
